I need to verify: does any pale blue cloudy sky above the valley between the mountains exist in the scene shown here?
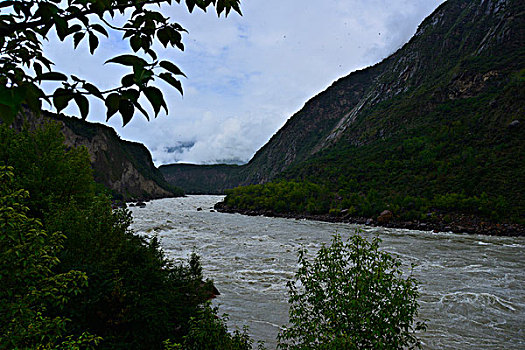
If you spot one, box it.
[45,0,443,165]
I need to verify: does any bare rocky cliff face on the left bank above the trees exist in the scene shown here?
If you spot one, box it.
[18,112,183,200]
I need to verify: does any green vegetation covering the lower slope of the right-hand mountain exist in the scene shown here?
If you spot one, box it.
[225,71,525,223]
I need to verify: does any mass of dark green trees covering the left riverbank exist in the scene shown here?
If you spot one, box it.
[0,124,254,349]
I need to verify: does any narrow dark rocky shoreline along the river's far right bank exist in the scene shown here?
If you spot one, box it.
[214,202,525,237]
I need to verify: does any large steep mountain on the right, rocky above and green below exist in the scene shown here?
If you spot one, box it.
[162,0,525,230]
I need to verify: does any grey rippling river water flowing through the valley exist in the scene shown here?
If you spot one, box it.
[131,196,525,350]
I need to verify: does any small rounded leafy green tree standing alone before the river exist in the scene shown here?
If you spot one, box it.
[278,234,425,350]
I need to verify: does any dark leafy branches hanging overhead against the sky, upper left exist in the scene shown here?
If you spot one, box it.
[0,0,241,125]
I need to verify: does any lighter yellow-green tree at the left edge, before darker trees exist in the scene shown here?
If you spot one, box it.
[0,166,100,349]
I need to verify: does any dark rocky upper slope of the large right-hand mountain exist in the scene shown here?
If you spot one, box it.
[243,0,525,184]
